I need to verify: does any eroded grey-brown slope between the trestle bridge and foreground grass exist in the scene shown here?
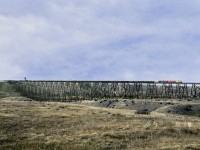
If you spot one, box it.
[93,99,200,117]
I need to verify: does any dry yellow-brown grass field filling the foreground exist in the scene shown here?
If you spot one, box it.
[0,98,200,150]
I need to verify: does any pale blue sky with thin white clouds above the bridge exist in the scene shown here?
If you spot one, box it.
[0,0,200,82]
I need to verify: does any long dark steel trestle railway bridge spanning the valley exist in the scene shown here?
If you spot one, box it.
[7,80,200,101]
